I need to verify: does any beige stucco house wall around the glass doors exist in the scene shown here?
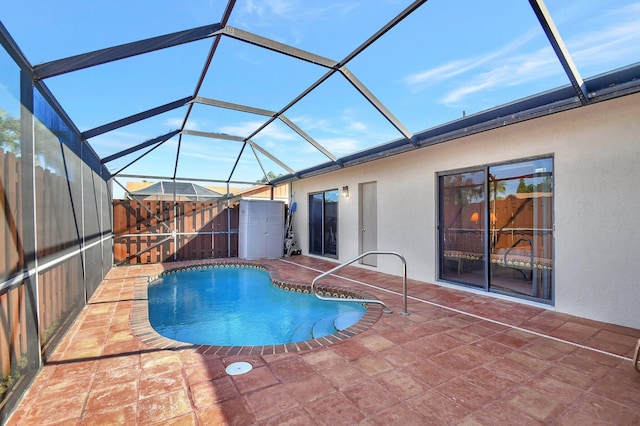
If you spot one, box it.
[292,94,640,328]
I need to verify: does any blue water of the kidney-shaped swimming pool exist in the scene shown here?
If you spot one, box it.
[148,266,365,346]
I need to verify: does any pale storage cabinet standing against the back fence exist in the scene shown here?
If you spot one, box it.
[238,200,284,260]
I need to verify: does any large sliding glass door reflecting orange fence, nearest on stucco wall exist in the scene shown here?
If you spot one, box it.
[439,158,553,303]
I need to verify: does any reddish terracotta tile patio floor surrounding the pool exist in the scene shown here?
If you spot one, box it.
[8,256,640,425]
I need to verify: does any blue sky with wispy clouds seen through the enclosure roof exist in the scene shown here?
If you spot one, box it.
[0,0,640,196]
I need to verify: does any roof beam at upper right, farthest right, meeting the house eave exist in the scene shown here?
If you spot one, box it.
[529,0,589,106]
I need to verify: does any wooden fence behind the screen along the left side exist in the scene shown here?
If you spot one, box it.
[0,149,84,402]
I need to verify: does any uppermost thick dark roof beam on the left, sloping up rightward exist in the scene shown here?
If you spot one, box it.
[33,23,221,80]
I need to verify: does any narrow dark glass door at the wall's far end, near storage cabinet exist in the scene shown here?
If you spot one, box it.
[309,189,338,257]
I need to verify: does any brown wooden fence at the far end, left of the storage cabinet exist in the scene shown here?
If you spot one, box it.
[113,200,240,264]
